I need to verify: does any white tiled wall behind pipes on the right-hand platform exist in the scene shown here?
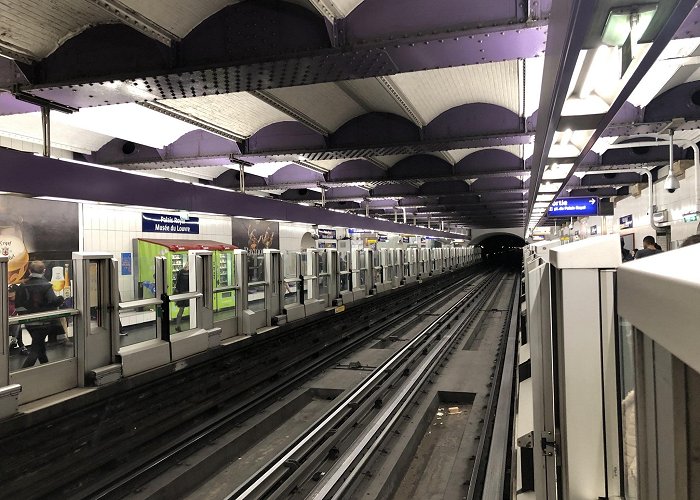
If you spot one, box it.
[613,163,698,248]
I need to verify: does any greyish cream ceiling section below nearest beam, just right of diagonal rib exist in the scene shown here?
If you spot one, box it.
[268,83,365,132]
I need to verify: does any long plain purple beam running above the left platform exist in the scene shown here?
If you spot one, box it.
[0,148,462,238]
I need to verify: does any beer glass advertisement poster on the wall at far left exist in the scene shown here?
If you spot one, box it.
[0,195,80,284]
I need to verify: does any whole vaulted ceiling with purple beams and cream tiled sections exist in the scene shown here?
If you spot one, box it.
[0,0,700,232]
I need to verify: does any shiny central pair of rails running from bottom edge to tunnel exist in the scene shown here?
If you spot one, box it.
[226,272,503,500]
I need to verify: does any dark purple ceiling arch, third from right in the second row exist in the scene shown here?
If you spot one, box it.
[245,121,326,154]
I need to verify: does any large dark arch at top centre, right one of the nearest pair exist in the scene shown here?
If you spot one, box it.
[180,0,331,67]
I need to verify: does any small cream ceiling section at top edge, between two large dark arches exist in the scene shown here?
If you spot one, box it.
[116,0,238,38]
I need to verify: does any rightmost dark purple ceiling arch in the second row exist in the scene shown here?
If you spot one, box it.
[425,103,522,139]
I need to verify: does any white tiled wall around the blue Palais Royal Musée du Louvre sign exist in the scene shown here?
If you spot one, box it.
[82,203,231,301]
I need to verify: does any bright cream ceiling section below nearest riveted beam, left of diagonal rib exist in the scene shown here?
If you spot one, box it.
[166,92,292,137]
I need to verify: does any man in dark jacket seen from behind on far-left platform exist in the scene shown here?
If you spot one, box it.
[16,260,63,368]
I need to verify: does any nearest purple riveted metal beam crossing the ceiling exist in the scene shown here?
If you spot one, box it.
[12,18,547,107]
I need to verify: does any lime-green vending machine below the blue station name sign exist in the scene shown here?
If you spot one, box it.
[135,238,237,317]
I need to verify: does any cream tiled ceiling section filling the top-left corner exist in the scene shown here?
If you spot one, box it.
[0,0,114,59]
